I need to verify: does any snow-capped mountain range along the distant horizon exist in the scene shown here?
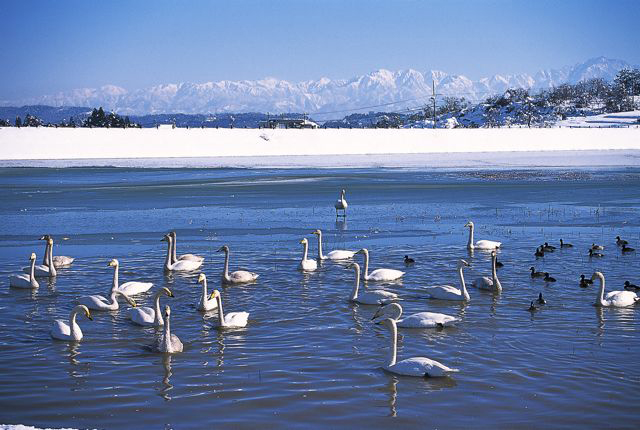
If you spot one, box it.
[3,57,633,118]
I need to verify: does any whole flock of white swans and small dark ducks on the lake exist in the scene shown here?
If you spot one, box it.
[9,190,640,377]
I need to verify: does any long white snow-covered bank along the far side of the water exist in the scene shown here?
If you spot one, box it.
[0,128,640,167]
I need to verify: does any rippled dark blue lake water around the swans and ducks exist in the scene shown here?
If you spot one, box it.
[0,168,640,429]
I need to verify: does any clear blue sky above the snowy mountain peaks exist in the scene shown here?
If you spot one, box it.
[0,0,640,100]
